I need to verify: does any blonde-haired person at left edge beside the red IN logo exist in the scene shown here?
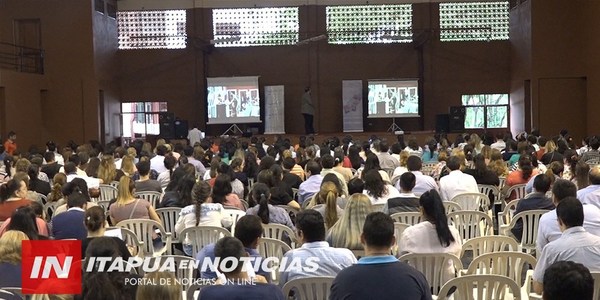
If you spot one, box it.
[0,230,29,288]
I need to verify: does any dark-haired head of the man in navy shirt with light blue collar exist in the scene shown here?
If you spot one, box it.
[362,212,394,249]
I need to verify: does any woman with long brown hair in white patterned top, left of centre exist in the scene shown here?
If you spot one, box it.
[175,179,232,255]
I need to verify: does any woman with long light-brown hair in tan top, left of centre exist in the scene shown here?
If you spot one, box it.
[109,176,161,224]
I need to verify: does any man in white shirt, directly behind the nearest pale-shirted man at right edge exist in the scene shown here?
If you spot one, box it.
[536,179,600,253]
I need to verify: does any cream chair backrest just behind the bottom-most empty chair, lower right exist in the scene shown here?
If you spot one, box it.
[467,251,537,285]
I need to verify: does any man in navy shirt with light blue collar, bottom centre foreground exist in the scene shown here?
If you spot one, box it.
[329,212,431,300]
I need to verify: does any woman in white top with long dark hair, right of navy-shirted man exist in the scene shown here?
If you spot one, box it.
[398,190,462,282]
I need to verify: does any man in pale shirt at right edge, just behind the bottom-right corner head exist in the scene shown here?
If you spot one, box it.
[533,197,600,294]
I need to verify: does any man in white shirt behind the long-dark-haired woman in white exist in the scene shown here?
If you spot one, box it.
[440,156,479,201]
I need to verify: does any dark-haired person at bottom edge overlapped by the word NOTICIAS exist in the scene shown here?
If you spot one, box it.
[200,237,285,300]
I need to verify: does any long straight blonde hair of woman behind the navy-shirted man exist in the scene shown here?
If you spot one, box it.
[325,193,372,250]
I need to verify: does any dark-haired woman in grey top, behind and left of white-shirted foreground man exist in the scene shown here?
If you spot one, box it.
[246,183,295,230]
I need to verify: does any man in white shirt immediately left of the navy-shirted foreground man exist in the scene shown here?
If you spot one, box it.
[279,209,356,287]
